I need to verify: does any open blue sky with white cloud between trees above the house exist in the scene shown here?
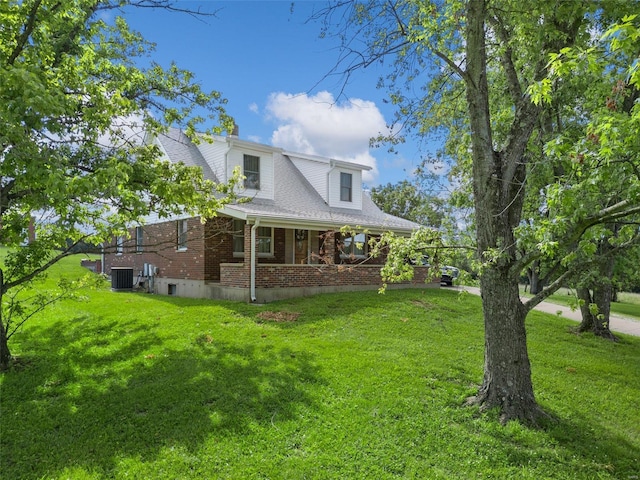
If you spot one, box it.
[126,0,440,187]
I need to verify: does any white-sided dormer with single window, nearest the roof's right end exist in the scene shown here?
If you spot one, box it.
[284,152,371,210]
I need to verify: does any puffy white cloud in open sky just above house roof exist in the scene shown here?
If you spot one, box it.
[266,92,387,183]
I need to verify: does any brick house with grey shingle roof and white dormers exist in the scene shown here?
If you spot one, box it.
[104,129,439,302]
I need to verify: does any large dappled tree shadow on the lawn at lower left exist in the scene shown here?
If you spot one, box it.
[0,317,318,479]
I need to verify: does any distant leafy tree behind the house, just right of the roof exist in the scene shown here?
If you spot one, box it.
[371,180,445,228]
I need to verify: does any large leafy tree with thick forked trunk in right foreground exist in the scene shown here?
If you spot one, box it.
[322,0,640,423]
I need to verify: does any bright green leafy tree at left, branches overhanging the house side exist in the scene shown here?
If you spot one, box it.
[0,0,238,367]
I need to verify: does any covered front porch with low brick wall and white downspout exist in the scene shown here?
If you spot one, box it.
[208,219,439,303]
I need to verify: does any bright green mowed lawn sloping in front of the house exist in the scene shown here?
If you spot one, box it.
[0,259,640,479]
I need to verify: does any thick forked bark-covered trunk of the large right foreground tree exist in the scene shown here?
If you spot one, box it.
[465,0,543,424]
